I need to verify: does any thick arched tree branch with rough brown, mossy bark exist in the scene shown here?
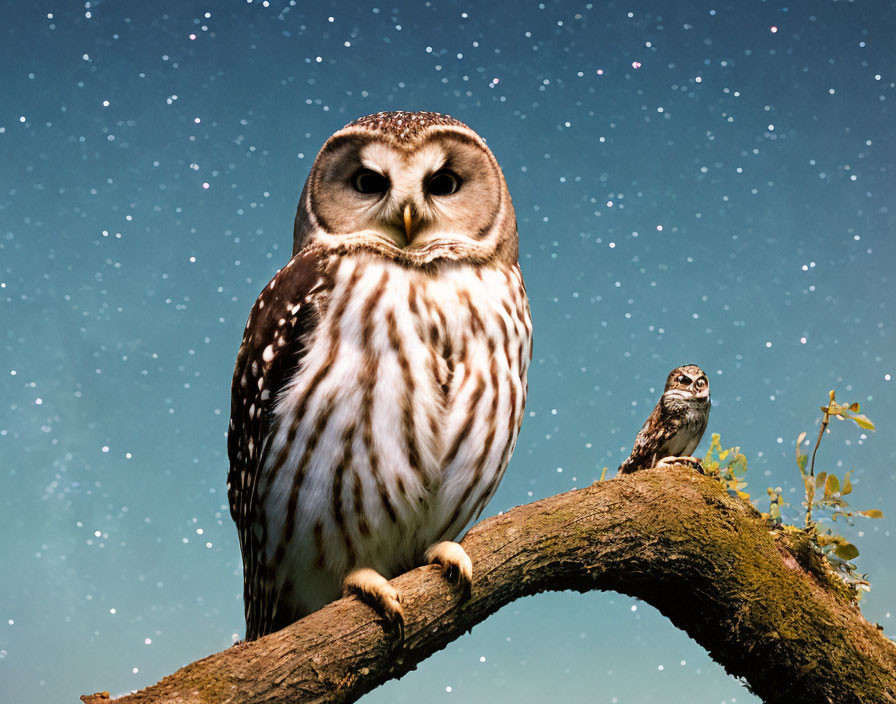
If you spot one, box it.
[82,467,896,704]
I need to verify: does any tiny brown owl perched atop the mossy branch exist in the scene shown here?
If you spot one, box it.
[619,364,710,474]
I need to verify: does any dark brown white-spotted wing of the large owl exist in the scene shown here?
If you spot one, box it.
[227,251,320,640]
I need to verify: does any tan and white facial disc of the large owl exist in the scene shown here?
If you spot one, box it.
[310,130,503,258]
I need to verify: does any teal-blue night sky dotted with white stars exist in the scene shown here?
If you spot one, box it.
[0,0,896,704]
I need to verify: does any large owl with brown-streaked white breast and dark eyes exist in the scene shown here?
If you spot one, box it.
[227,112,532,640]
